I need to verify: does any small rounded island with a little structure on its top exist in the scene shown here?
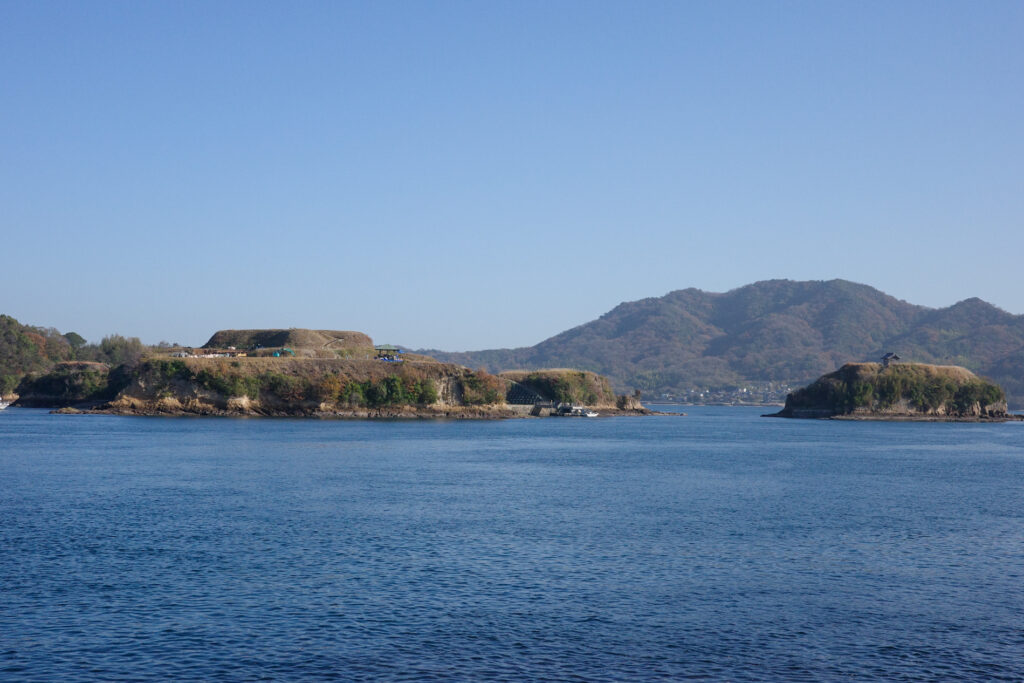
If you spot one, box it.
[764,354,1024,422]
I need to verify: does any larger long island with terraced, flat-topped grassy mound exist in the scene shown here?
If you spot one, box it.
[16,329,650,419]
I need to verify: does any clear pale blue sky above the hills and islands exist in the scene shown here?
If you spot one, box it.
[0,0,1024,350]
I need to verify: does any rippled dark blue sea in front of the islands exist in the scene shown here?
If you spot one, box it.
[0,408,1024,681]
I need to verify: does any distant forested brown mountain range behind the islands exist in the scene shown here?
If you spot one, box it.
[421,280,1024,405]
